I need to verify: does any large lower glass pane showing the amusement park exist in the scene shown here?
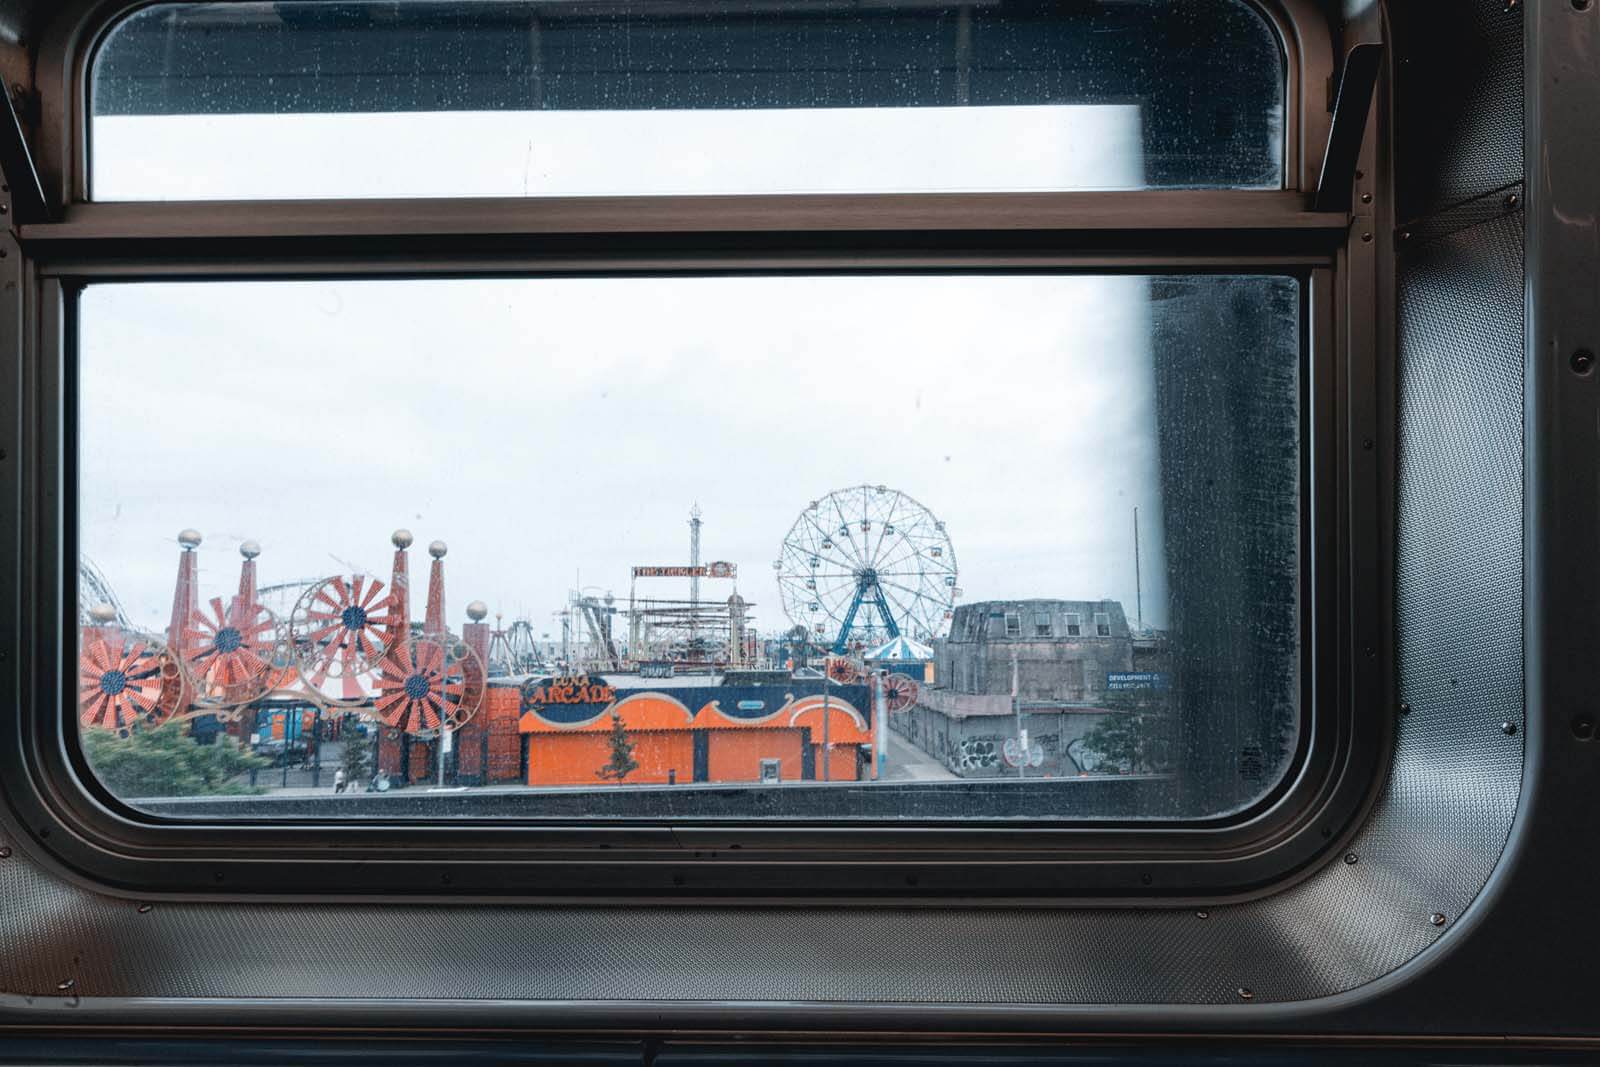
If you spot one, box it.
[75,274,1304,821]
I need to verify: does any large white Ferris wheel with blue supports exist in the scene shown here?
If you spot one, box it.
[773,485,962,653]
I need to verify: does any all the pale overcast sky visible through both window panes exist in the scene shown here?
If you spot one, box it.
[80,107,1165,632]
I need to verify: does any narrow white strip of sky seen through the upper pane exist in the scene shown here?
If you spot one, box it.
[90,104,1144,200]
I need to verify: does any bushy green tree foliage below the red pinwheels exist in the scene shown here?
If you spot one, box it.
[82,723,270,798]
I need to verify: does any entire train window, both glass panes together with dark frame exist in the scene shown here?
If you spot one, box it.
[0,0,1356,894]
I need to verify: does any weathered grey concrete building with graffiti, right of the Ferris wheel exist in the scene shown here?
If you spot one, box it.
[890,600,1166,777]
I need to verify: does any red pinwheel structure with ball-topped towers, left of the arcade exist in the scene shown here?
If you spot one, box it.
[78,530,490,774]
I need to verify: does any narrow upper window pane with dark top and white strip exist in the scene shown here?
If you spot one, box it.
[90,0,1285,200]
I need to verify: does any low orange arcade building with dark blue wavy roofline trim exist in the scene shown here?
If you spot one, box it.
[482,675,872,785]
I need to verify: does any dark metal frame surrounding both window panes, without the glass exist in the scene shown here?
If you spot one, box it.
[0,0,1392,904]
